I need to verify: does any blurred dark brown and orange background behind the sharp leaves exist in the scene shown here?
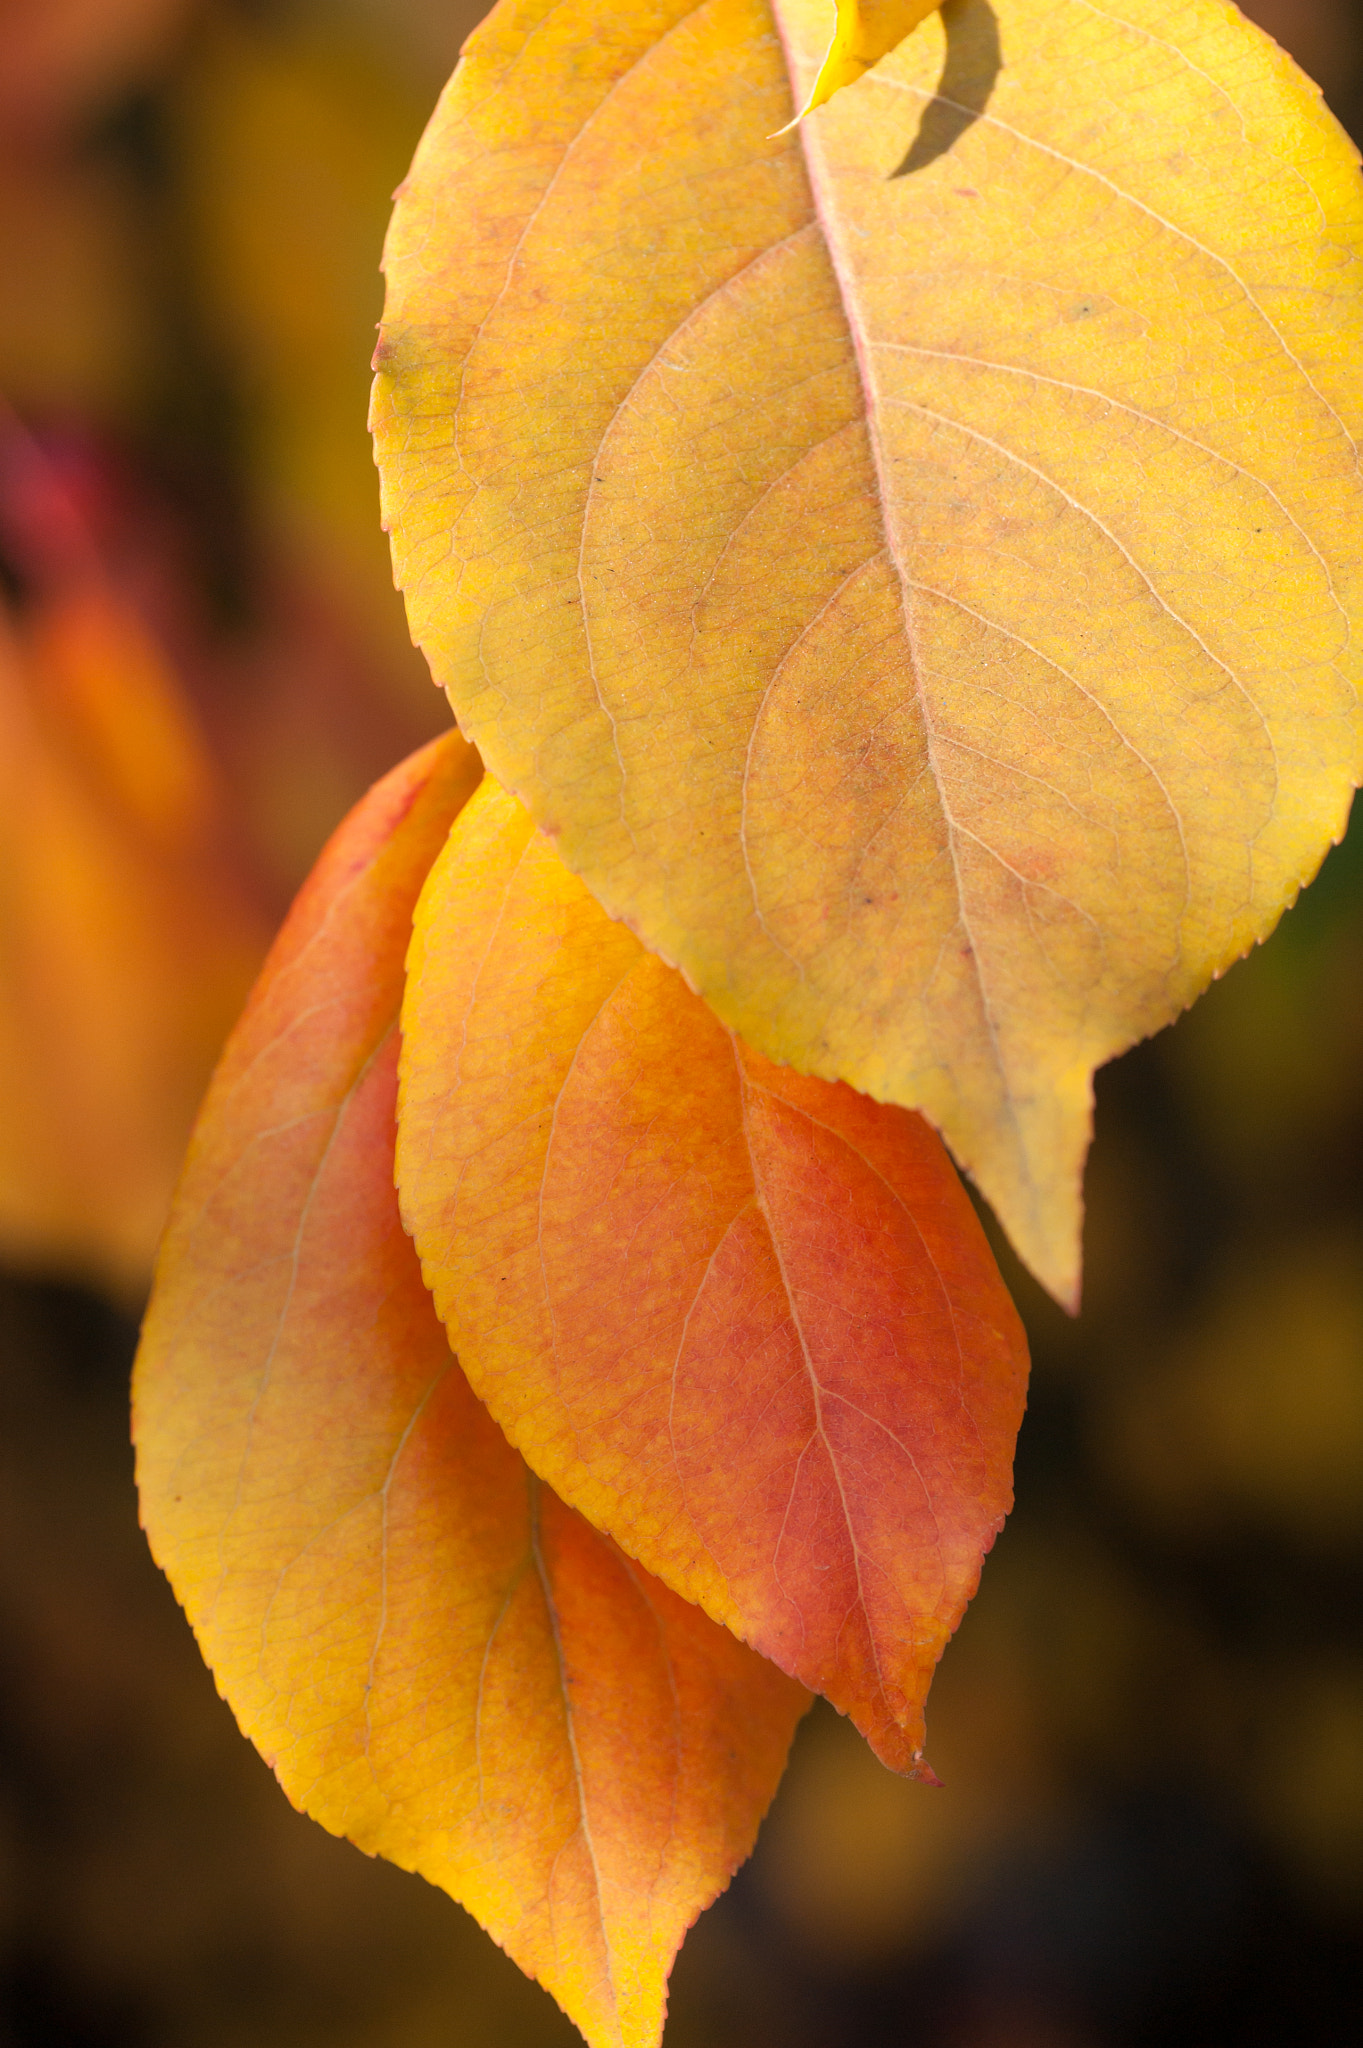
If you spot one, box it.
[0,0,1363,2048]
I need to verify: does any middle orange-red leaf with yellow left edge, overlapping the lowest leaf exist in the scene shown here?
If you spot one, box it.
[397,780,1025,1769]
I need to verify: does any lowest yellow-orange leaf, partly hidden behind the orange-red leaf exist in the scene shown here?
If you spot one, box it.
[135,735,806,2048]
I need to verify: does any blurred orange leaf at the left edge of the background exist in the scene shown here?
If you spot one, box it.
[0,414,266,1300]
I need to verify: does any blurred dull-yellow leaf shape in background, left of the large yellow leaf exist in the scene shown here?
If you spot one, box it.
[174,12,435,731]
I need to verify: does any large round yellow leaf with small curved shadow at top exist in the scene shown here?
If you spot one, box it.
[372,0,1363,1303]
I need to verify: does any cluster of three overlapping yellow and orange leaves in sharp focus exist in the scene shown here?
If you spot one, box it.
[137,0,1361,2048]
